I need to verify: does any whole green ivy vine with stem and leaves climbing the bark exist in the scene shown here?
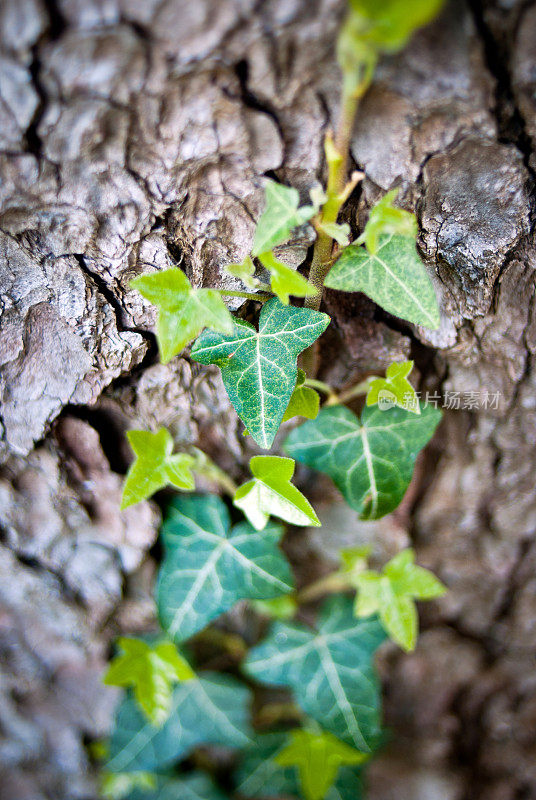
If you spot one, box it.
[98,0,445,800]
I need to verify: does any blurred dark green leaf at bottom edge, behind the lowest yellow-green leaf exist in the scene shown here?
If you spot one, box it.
[236,733,363,800]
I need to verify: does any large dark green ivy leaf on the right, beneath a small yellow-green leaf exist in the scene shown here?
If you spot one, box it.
[285,405,441,519]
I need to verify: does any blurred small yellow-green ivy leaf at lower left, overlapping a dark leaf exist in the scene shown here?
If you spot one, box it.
[103,637,195,725]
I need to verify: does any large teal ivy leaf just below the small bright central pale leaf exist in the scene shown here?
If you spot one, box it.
[157,495,293,641]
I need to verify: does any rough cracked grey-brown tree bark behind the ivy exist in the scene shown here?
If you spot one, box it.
[0,0,536,800]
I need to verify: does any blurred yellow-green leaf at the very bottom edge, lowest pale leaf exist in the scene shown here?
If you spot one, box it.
[275,729,367,800]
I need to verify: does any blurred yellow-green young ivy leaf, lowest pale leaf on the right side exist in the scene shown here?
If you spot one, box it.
[352,548,446,652]
